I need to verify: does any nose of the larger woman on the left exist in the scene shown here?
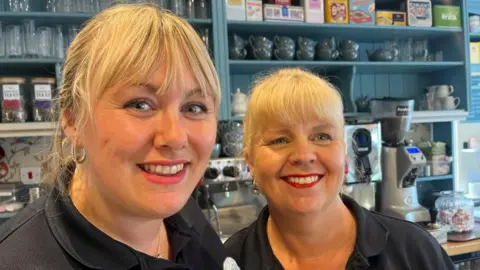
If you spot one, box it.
[154,111,188,150]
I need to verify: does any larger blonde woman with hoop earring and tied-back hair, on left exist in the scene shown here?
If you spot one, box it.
[0,4,232,269]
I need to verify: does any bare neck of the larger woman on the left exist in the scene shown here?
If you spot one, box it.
[69,169,168,257]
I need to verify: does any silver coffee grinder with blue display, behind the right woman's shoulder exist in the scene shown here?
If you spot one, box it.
[370,98,431,222]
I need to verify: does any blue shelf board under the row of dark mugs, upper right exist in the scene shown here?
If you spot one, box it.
[229,60,464,74]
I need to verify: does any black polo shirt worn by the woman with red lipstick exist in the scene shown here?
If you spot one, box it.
[225,196,454,270]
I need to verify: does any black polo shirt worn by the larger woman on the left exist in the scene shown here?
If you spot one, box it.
[0,189,226,270]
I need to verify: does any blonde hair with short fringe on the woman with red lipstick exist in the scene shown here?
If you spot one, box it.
[243,68,344,154]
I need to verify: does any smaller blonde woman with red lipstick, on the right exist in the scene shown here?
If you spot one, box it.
[225,68,453,270]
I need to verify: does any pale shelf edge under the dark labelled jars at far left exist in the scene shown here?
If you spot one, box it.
[0,122,56,138]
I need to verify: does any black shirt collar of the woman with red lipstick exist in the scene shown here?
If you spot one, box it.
[255,195,389,269]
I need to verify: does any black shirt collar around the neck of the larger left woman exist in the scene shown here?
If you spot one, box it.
[45,189,190,269]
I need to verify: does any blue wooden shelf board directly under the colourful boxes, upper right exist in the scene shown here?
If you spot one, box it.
[228,21,462,42]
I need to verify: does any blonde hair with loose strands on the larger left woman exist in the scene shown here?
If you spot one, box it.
[45,4,221,190]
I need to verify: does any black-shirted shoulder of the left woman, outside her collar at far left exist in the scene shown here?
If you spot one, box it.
[0,198,70,269]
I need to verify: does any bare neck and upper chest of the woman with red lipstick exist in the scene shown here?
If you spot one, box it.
[267,197,356,260]
